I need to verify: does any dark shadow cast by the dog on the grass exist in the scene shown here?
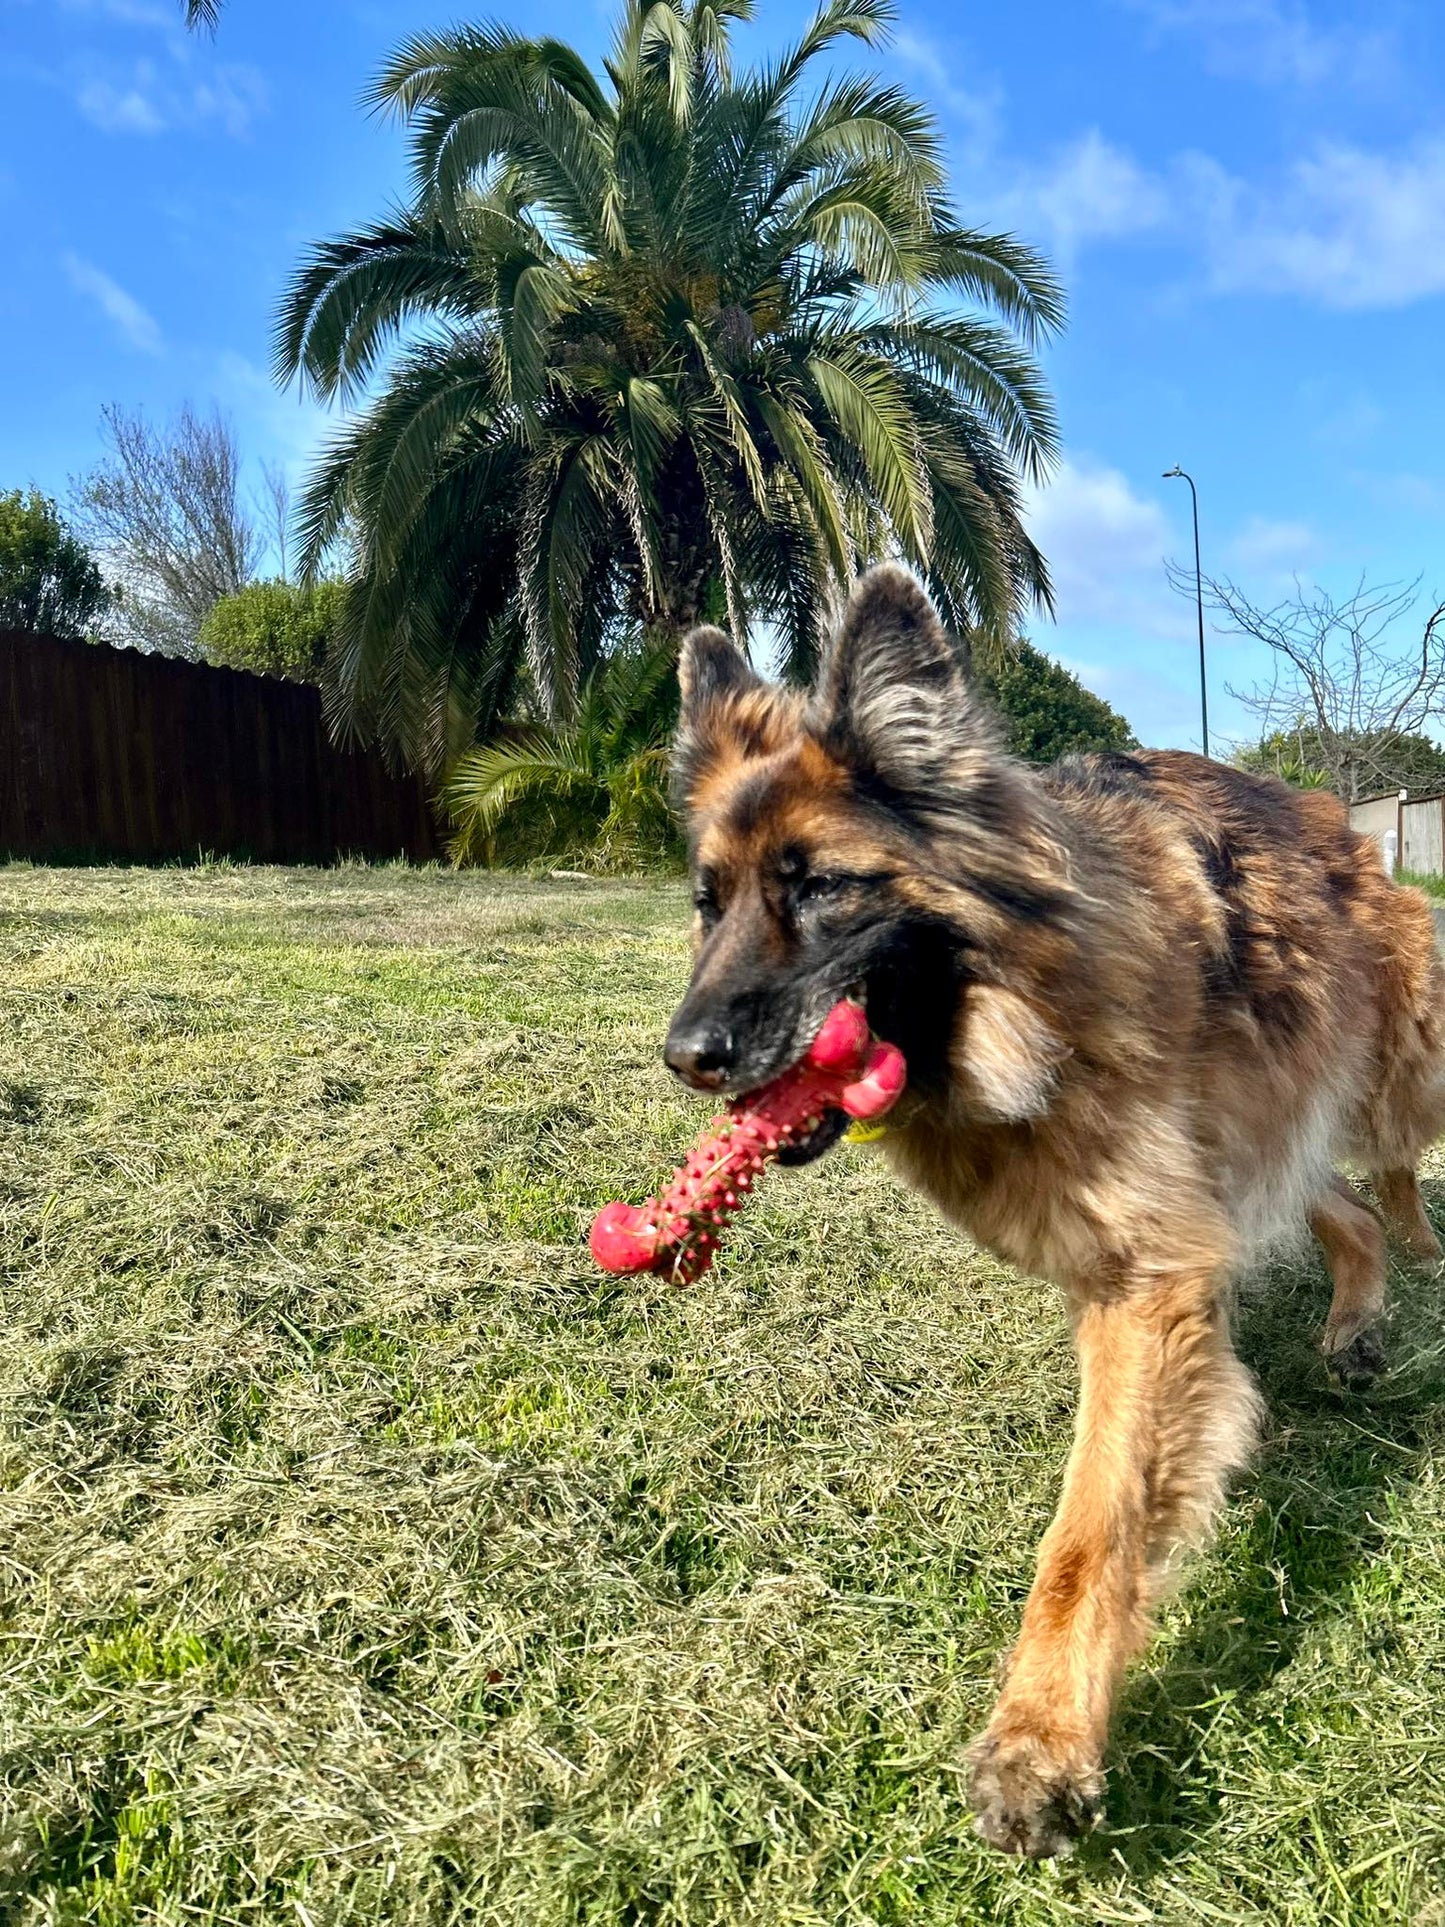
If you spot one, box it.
[1081,1187,1445,1879]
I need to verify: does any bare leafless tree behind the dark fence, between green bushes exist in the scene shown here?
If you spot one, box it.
[71,403,262,655]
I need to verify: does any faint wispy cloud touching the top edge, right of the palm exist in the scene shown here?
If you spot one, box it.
[1125,0,1399,92]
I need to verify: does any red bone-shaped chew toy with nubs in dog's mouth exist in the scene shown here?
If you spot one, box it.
[591,1000,907,1285]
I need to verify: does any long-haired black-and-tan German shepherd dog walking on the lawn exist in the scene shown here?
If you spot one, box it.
[667,567,1445,1856]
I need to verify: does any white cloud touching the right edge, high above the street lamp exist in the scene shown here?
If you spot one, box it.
[1193,141,1445,308]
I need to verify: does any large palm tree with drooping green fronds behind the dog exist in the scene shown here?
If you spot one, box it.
[276,0,1062,767]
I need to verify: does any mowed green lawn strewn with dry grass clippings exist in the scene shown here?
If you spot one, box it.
[0,867,1445,1927]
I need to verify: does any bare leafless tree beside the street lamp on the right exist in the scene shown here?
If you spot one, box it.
[1169,567,1445,802]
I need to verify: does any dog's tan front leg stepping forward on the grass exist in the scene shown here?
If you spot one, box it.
[971,1274,1254,1856]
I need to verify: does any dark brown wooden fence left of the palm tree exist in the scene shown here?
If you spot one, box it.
[0,630,437,863]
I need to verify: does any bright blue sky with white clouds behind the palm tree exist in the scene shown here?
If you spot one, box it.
[0,0,1445,744]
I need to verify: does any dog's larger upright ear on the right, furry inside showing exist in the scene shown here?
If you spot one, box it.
[809,563,992,794]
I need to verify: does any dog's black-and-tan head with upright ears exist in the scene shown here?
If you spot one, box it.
[665,567,1078,1152]
